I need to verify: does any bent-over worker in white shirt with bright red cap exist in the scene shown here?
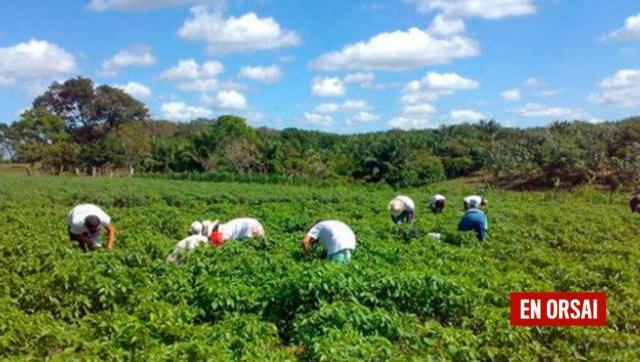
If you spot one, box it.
[189,217,264,246]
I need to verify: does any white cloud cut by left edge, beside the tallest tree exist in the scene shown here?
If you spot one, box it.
[0,39,78,87]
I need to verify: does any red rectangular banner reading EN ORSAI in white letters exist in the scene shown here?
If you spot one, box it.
[509,292,607,327]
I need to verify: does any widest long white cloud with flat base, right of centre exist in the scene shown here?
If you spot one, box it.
[311,28,480,71]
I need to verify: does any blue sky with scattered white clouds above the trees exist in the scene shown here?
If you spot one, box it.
[0,0,640,133]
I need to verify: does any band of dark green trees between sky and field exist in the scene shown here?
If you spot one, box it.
[0,77,640,189]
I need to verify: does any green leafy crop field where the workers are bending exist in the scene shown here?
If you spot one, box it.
[0,175,640,361]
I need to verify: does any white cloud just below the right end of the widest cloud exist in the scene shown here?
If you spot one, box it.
[400,72,480,104]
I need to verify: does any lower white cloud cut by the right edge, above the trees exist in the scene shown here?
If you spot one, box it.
[589,69,640,108]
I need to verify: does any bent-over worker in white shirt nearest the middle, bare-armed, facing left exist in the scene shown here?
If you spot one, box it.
[301,220,356,264]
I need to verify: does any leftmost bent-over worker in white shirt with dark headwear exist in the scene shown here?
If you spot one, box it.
[68,204,116,251]
